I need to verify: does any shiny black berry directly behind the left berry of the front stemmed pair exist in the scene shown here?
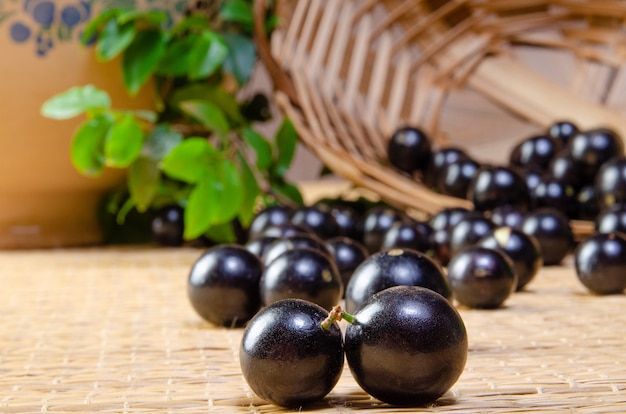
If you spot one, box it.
[259,248,344,310]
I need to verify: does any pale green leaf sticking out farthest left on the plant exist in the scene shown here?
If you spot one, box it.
[41,85,111,119]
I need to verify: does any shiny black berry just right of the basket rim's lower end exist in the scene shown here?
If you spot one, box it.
[467,165,530,211]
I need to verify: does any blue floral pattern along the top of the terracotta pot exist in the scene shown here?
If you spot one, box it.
[0,0,188,56]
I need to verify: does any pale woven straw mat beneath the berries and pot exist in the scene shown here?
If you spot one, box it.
[0,244,626,413]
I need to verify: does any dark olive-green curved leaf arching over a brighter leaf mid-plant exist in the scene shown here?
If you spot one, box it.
[170,83,246,124]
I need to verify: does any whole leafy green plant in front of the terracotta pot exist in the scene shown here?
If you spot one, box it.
[42,0,302,242]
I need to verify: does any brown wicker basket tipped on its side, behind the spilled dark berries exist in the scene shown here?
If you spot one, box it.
[255,0,626,236]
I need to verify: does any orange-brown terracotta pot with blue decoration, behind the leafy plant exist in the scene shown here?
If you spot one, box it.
[0,0,183,248]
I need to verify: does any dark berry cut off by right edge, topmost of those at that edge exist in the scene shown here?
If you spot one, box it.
[595,156,626,208]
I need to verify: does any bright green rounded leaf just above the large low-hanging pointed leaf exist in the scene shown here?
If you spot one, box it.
[161,137,220,184]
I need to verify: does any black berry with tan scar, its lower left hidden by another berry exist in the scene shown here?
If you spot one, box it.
[476,227,543,291]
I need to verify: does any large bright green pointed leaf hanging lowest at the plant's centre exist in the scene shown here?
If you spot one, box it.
[185,160,241,239]
